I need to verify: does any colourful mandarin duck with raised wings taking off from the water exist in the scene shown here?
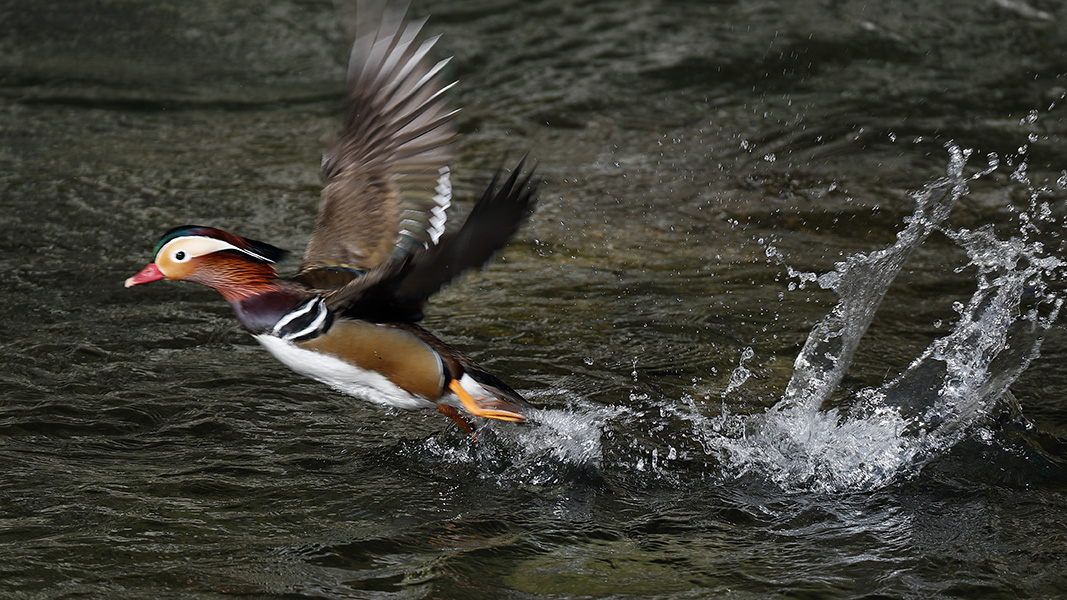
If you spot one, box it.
[125,1,540,439]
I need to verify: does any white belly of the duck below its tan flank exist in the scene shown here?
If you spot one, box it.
[255,334,435,409]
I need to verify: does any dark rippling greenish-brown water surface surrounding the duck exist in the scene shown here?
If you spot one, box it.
[0,0,1067,599]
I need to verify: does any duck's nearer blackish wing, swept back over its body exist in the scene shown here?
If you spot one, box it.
[327,161,540,320]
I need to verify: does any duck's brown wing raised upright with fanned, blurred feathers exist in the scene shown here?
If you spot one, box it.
[301,2,457,271]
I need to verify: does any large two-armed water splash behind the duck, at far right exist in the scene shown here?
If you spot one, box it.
[717,146,1065,491]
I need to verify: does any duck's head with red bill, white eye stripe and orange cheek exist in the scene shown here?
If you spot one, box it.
[126,225,288,294]
